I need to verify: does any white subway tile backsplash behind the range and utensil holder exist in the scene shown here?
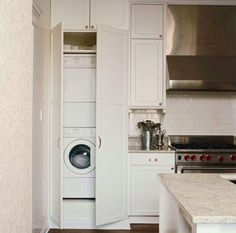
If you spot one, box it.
[129,92,236,136]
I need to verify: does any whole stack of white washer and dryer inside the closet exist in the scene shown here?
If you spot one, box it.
[63,54,96,198]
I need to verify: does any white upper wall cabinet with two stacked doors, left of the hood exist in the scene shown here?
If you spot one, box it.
[130,4,165,109]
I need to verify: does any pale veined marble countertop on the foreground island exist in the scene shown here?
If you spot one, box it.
[159,173,236,224]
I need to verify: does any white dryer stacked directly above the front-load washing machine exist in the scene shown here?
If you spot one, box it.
[63,54,96,127]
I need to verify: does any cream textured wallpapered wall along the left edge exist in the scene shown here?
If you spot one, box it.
[0,0,32,233]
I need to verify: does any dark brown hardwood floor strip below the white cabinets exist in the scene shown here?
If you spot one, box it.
[49,224,159,233]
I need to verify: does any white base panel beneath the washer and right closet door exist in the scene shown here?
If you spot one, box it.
[62,217,130,230]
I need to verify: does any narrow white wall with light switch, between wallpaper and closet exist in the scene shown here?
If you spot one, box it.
[32,0,50,233]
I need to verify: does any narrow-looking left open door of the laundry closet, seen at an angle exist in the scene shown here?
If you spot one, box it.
[50,24,63,227]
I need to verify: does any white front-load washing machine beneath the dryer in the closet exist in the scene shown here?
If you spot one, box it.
[63,128,96,198]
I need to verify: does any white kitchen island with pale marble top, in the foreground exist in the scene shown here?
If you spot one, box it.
[159,173,236,233]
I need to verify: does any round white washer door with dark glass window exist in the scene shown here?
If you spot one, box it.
[64,139,95,174]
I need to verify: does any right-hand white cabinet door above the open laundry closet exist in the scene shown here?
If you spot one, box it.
[90,0,129,29]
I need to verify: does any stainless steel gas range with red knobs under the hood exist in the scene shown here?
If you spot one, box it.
[169,136,236,172]
